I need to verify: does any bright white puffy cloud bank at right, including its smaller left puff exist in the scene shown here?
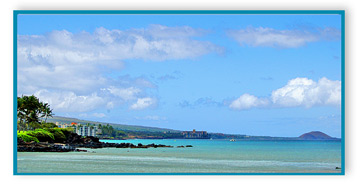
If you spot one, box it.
[229,77,341,110]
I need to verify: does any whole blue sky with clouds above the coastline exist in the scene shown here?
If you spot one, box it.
[17,14,341,138]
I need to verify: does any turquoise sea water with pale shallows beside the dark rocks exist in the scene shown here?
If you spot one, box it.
[18,139,341,173]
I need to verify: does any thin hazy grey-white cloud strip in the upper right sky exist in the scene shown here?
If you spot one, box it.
[228,27,341,48]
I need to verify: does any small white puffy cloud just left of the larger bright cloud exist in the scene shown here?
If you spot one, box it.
[229,94,269,110]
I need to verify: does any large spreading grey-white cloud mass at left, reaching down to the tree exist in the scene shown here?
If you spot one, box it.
[17,25,222,112]
